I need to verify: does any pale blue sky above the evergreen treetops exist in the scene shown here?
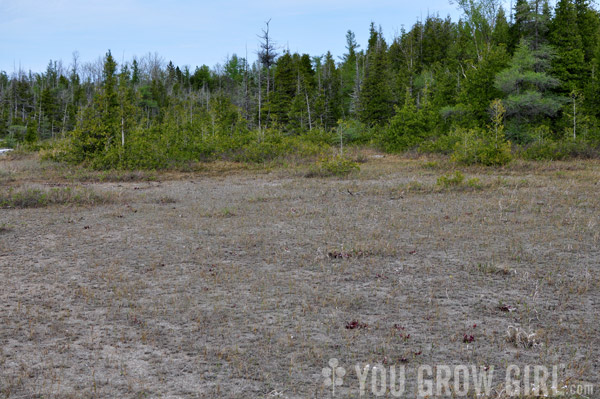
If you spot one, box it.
[0,0,460,75]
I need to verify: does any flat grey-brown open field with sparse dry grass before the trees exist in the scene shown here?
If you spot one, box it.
[0,153,600,398]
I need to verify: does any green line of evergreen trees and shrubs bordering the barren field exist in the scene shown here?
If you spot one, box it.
[0,0,600,167]
